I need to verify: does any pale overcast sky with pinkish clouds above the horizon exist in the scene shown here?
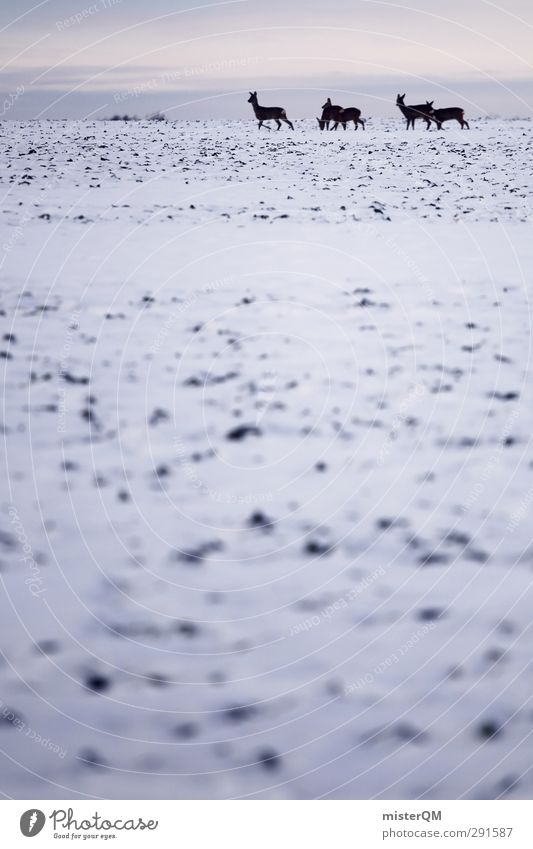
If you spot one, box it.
[0,0,533,119]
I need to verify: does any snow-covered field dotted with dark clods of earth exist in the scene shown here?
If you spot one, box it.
[0,115,533,799]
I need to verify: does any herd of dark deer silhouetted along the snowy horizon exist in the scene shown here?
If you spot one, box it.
[248,91,470,130]
